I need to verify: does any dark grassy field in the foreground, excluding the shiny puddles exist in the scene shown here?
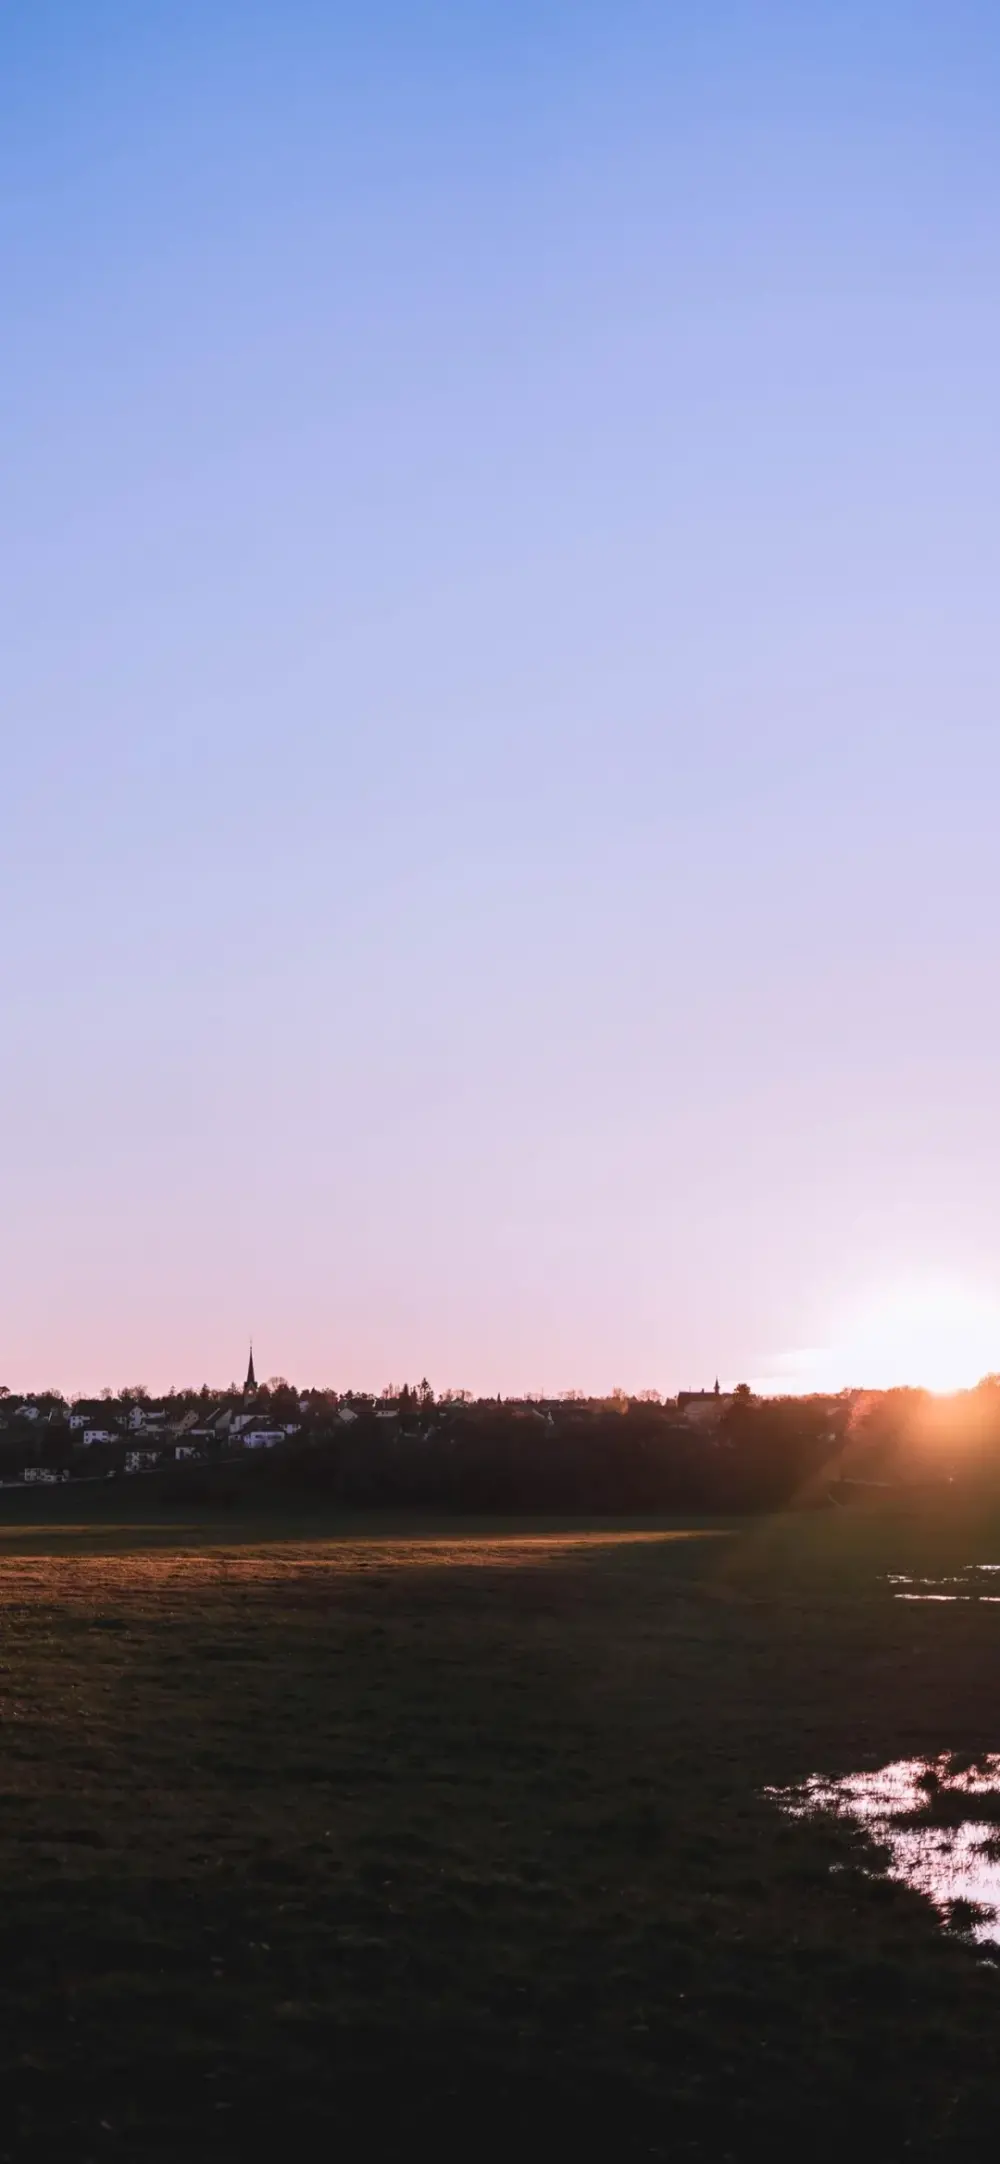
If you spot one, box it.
[0,1497,1000,2164]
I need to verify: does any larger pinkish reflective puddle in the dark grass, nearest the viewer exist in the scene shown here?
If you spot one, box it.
[779,1753,1000,1945]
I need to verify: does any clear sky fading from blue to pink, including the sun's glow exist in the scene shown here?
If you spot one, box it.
[0,0,1000,1394]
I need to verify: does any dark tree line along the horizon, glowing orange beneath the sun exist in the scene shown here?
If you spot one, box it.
[0,1376,1000,1515]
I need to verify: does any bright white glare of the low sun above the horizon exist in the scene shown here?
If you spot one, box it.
[753,1281,1000,1391]
